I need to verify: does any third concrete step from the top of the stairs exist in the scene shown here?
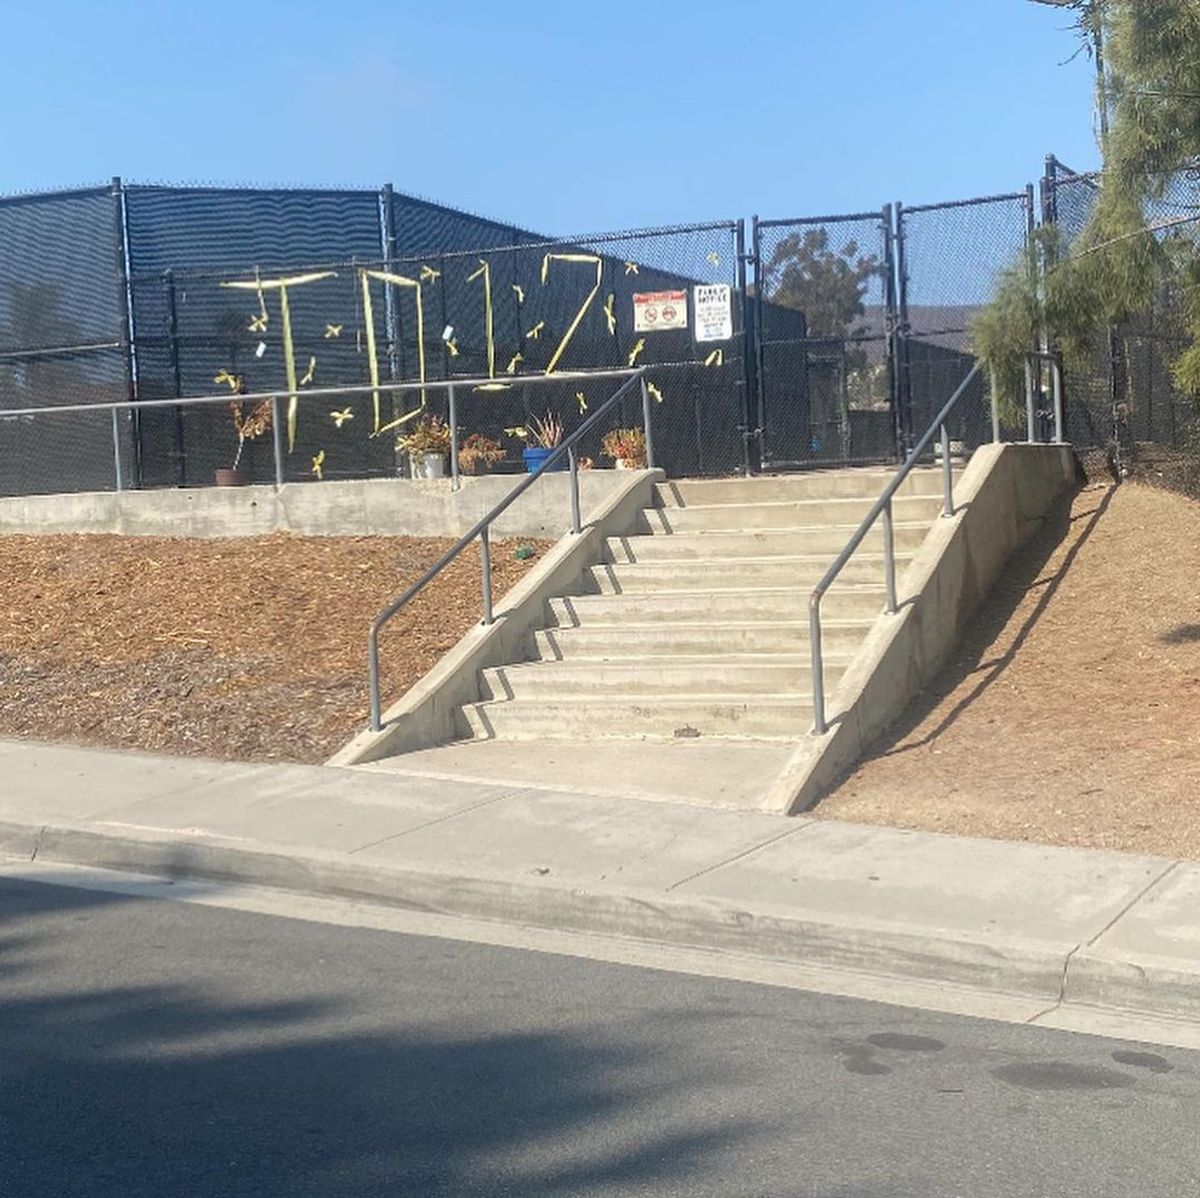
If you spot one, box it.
[605,521,929,562]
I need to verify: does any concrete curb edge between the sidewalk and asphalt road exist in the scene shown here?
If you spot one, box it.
[0,821,1099,1017]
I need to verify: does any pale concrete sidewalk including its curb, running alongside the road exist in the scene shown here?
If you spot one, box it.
[0,742,1200,1035]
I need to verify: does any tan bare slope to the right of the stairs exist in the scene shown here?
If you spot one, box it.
[815,484,1200,858]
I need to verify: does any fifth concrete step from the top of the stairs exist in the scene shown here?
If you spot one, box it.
[550,581,884,628]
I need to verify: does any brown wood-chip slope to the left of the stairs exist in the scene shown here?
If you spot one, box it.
[0,534,545,762]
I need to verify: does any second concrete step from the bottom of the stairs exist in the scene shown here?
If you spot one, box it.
[480,654,846,700]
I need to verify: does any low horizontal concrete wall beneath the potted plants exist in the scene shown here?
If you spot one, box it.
[0,471,648,538]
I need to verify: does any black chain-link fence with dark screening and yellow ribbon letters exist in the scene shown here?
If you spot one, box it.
[14,158,1200,495]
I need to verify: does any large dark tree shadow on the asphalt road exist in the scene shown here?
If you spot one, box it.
[0,879,755,1198]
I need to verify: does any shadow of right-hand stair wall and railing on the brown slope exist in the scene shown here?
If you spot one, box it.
[863,487,1116,763]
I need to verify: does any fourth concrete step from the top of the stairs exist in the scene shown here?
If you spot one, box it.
[587,552,912,594]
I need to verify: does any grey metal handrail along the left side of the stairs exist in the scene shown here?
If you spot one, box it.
[367,366,654,732]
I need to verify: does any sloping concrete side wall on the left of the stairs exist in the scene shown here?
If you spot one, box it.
[328,471,666,766]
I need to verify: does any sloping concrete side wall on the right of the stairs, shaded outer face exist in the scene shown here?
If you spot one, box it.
[766,445,1079,814]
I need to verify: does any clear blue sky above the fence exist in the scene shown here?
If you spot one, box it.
[0,0,1097,234]
